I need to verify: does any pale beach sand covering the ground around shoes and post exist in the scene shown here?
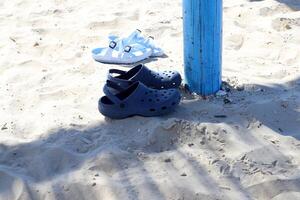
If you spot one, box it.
[0,0,300,200]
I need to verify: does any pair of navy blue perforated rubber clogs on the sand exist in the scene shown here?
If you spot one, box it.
[98,64,182,119]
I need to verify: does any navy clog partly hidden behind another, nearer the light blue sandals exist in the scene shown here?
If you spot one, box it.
[107,64,182,89]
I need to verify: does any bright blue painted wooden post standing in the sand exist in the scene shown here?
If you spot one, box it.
[183,0,223,95]
